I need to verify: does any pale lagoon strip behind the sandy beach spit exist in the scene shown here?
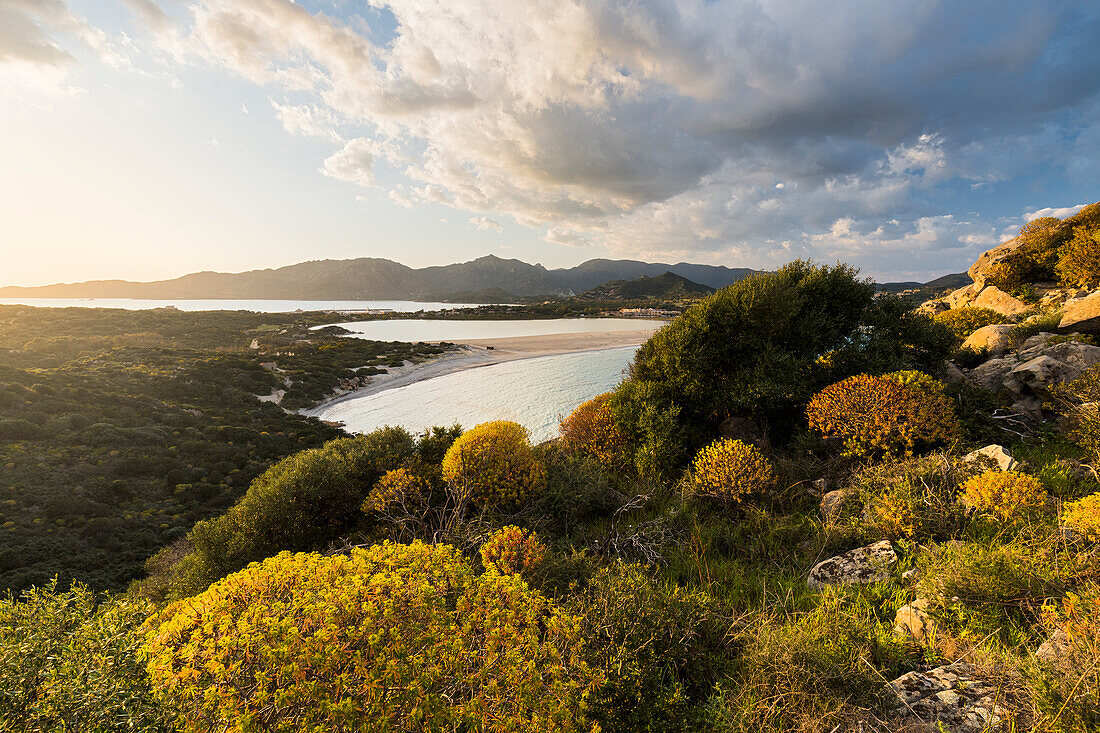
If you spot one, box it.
[338,318,667,342]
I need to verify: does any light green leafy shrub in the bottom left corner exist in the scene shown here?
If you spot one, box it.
[0,582,172,733]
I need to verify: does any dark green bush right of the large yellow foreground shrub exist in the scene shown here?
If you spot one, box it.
[569,562,733,733]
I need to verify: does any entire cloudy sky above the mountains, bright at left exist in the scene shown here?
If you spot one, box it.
[0,0,1100,285]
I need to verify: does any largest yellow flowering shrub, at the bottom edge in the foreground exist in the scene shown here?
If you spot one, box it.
[144,543,598,733]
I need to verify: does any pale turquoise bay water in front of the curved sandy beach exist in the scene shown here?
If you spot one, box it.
[318,347,637,441]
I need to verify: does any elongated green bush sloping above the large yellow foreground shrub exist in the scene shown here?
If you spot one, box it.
[146,427,416,599]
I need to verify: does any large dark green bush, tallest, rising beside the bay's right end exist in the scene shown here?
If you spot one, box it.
[613,261,952,473]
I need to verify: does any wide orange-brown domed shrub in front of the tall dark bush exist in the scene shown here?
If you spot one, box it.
[806,374,959,456]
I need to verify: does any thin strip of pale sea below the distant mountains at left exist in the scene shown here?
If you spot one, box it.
[0,298,476,313]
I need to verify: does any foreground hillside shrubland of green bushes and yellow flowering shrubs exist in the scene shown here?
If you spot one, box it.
[0,248,1100,733]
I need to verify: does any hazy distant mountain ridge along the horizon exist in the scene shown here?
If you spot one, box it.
[0,254,757,300]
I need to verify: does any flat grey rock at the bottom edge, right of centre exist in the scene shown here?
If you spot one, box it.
[890,661,1010,733]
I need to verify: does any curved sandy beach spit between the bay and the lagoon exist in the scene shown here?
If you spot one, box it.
[298,328,657,419]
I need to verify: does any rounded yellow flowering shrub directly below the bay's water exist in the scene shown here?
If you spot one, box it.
[440,420,546,506]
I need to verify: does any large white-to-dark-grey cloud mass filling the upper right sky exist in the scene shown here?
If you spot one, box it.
[167,0,1100,274]
